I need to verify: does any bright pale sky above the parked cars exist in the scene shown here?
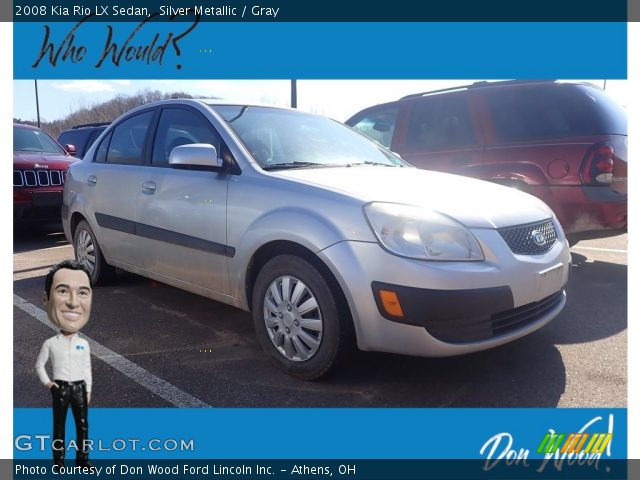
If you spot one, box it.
[13,80,628,121]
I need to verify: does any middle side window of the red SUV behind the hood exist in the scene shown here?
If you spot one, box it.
[406,95,476,151]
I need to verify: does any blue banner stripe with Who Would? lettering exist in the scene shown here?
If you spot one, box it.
[14,21,627,79]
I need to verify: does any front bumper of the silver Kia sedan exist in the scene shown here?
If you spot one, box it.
[320,229,571,356]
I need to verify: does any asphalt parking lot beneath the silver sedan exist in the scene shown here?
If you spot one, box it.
[13,225,627,407]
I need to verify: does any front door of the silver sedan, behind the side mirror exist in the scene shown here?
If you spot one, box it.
[136,106,230,297]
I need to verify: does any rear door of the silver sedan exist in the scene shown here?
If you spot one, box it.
[85,109,156,267]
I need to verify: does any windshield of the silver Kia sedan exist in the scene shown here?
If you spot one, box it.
[211,105,406,170]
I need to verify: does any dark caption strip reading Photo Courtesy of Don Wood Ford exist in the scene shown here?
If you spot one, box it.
[13,460,628,480]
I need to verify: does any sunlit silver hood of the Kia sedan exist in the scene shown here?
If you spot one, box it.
[277,166,553,228]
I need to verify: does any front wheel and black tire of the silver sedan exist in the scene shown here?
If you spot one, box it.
[251,255,351,380]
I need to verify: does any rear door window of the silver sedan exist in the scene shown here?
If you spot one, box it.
[106,111,154,165]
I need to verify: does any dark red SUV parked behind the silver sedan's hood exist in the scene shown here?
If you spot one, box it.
[346,81,627,243]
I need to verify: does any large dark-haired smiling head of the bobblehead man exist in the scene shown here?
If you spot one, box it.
[44,268,92,333]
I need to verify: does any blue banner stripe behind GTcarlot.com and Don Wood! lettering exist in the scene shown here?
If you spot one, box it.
[14,408,627,460]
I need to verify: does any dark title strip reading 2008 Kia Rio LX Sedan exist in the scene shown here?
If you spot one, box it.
[10,0,628,22]
